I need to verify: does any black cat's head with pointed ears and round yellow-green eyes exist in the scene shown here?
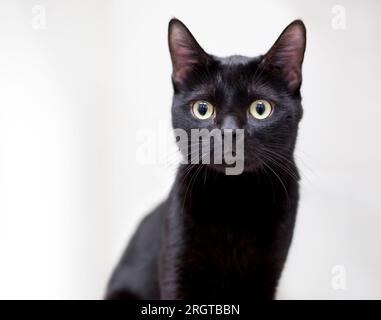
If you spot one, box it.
[168,19,306,171]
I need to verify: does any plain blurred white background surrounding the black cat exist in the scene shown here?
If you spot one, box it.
[0,0,381,299]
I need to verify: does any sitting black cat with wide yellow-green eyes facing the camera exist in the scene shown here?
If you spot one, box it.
[106,19,306,299]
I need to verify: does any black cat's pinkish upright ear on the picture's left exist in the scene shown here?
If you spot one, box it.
[168,18,210,84]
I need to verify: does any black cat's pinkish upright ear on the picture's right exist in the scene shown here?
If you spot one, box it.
[261,20,306,92]
